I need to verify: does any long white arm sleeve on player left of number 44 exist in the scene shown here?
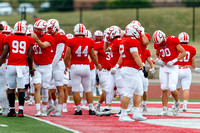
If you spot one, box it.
[52,43,65,68]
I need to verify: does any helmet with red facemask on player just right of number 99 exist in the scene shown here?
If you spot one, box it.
[33,19,47,37]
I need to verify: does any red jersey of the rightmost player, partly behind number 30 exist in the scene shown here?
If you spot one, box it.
[178,44,196,65]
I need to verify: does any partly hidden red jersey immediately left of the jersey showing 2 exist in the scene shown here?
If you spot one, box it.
[110,38,122,67]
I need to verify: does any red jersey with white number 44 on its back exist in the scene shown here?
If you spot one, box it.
[67,37,94,65]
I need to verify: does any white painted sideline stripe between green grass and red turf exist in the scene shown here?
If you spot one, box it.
[24,114,80,133]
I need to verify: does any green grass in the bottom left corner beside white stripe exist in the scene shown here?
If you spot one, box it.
[0,116,71,133]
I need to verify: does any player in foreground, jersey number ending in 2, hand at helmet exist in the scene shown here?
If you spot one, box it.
[119,24,146,122]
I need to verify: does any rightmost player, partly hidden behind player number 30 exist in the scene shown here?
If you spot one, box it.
[177,32,198,112]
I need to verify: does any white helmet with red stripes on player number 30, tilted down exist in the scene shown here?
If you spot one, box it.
[153,30,166,45]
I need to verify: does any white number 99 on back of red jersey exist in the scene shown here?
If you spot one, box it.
[12,40,26,54]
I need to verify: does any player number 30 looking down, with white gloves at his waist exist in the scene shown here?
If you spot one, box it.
[153,30,186,116]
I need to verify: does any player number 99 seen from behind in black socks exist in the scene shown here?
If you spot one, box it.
[0,21,35,117]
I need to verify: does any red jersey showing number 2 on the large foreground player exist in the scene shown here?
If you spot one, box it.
[120,37,141,69]
